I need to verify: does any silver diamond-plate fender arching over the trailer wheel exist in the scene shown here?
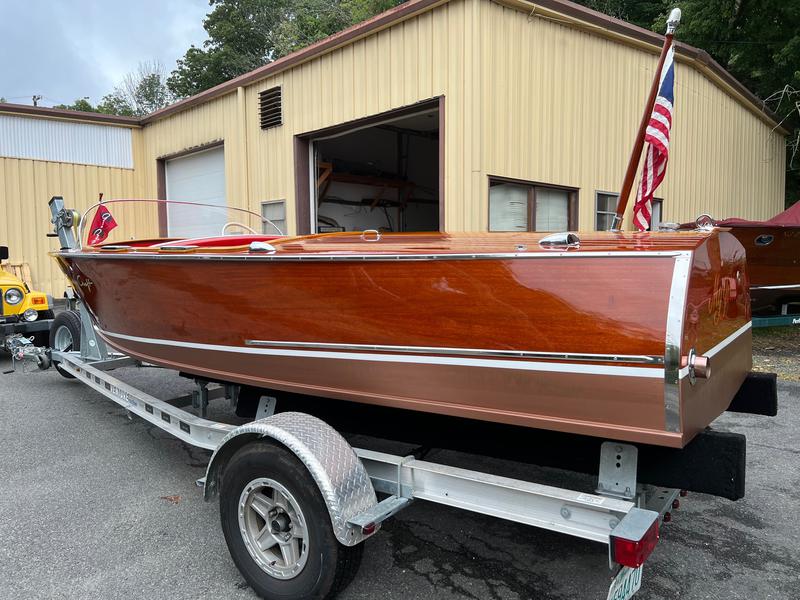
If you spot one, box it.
[204,412,378,546]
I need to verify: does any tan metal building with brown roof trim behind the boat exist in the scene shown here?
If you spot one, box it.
[0,0,785,294]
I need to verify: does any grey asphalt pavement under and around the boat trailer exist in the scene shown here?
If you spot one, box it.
[0,355,800,600]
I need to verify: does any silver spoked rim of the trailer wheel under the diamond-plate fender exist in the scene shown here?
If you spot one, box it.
[239,477,309,579]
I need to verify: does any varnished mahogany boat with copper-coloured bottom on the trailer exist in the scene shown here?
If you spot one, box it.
[54,213,751,447]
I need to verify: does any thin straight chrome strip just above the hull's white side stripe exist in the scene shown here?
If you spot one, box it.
[244,340,664,365]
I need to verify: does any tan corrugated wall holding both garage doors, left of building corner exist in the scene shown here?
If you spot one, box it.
[137,0,472,233]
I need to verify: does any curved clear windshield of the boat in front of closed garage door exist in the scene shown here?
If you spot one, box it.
[80,199,285,246]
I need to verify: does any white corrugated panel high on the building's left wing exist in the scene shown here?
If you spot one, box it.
[0,114,133,169]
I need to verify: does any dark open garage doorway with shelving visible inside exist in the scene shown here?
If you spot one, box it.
[300,100,443,233]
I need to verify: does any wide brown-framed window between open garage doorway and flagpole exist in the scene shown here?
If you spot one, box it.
[489,177,578,231]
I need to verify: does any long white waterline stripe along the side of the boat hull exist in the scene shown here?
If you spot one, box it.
[98,328,664,380]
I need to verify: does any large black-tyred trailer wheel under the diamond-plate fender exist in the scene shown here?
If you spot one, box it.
[219,442,364,600]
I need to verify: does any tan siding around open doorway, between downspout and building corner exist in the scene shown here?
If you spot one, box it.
[246,2,467,231]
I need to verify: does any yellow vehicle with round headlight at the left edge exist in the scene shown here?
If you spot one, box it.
[0,246,53,350]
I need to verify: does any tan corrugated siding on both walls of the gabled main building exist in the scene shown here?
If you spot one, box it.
[137,0,784,232]
